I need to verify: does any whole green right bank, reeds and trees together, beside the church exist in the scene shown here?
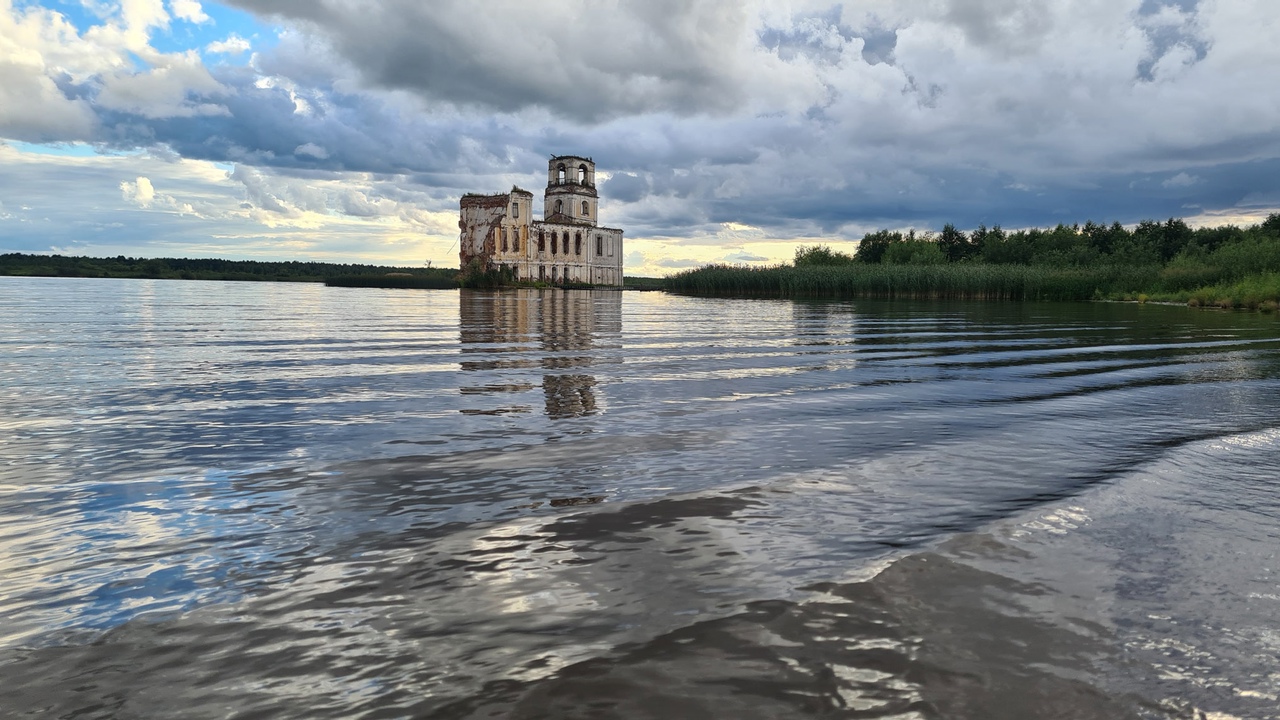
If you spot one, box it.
[667,214,1280,304]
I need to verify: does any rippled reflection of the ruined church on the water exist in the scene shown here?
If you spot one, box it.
[458,288,622,419]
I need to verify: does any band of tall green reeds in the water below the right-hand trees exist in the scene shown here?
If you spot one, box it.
[667,263,1160,300]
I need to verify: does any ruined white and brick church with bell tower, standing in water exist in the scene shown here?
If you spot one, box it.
[458,155,622,287]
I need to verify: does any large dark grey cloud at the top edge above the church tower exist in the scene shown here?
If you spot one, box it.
[220,0,746,119]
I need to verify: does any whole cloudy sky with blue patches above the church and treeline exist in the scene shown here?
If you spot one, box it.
[0,0,1280,274]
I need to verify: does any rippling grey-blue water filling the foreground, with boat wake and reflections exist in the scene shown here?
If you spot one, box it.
[0,278,1280,720]
